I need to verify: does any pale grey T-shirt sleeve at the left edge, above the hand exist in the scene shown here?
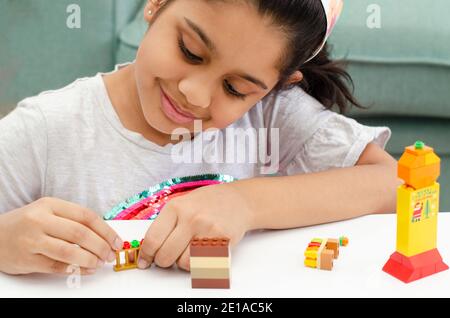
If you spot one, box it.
[0,102,47,214]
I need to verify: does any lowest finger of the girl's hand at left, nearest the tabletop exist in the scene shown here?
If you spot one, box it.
[32,255,96,275]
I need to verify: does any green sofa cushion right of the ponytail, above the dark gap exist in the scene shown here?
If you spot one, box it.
[329,0,450,118]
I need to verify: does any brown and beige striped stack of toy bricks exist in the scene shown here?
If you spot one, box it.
[190,238,230,288]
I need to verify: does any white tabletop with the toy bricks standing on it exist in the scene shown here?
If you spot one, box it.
[0,213,450,298]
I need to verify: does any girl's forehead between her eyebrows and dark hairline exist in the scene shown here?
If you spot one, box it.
[168,0,285,77]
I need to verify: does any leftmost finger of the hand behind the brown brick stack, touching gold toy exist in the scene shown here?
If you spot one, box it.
[138,205,177,269]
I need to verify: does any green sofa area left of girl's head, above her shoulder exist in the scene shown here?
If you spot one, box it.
[0,0,144,117]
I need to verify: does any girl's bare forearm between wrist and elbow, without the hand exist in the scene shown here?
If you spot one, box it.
[230,164,400,229]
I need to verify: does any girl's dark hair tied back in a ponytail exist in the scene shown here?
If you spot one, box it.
[155,0,365,113]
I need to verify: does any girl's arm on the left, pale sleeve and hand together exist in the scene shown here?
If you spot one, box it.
[0,103,122,275]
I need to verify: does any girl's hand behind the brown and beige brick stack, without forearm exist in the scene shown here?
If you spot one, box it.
[138,183,252,270]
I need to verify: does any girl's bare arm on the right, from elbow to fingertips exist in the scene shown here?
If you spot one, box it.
[139,144,400,270]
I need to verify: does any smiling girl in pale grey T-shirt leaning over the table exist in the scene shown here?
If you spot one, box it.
[0,0,398,274]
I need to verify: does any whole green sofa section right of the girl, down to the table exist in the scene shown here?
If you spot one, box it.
[330,0,450,212]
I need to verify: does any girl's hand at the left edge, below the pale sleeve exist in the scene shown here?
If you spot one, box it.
[0,198,122,275]
